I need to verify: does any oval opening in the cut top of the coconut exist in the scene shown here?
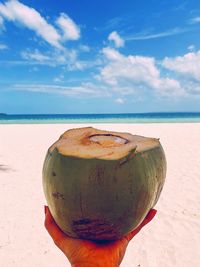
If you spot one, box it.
[89,134,129,147]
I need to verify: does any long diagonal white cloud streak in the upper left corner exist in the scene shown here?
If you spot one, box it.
[0,0,61,48]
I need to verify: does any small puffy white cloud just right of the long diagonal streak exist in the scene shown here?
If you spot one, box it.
[56,13,80,40]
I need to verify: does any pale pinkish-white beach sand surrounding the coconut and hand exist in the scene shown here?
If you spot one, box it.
[0,123,200,267]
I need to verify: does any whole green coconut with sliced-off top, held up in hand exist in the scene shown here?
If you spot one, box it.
[43,127,166,240]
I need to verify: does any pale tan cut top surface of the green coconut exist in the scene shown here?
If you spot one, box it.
[50,127,160,160]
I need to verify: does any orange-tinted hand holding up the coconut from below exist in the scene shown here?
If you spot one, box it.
[45,206,157,267]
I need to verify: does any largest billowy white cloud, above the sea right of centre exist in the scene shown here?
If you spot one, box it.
[98,47,184,95]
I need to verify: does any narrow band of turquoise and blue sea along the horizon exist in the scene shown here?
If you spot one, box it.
[0,112,200,124]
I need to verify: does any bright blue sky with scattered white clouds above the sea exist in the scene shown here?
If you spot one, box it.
[0,0,200,114]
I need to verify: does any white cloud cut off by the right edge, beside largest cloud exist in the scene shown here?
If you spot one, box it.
[162,50,200,82]
